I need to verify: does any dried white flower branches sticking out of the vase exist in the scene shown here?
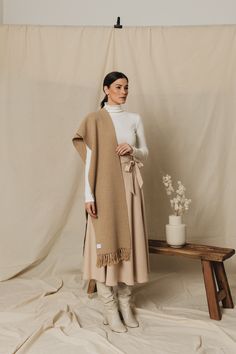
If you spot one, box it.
[162,175,192,215]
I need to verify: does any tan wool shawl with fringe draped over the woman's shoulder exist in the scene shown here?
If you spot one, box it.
[72,107,131,267]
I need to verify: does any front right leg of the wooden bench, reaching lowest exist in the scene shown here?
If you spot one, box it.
[201,260,222,321]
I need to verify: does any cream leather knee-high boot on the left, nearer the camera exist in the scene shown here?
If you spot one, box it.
[96,281,127,333]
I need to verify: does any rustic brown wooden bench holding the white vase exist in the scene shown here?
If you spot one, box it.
[87,240,235,320]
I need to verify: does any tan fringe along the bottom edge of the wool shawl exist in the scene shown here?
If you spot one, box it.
[97,248,130,268]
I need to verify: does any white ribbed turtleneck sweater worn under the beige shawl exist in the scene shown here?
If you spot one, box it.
[85,103,148,202]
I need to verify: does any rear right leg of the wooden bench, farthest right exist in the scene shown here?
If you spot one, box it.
[213,262,234,309]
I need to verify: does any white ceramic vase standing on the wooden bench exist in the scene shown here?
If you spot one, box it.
[166,215,186,248]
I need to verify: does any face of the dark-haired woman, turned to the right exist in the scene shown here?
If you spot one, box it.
[104,79,128,105]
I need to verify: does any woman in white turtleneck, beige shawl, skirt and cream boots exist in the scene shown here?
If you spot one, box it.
[72,71,150,332]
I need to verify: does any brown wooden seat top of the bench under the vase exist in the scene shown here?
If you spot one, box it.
[148,239,235,262]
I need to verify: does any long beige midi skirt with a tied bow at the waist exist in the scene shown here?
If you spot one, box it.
[83,155,150,286]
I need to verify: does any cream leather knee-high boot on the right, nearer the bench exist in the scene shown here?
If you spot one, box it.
[117,283,139,328]
